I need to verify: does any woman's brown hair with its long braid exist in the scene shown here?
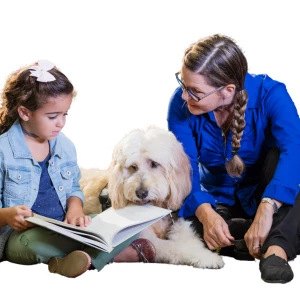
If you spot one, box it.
[183,34,248,177]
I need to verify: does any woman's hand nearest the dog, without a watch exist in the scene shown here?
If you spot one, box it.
[196,203,234,250]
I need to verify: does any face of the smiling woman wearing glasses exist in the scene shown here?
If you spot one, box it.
[181,67,228,115]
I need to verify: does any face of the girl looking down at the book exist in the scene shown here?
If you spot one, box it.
[22,94,73,140]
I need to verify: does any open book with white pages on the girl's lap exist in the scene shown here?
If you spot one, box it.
[26,204,172,252]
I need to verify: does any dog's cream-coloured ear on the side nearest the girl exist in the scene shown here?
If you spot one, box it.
[108,161,128,209]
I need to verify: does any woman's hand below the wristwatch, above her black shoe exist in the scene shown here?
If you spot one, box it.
[245,203,274,259]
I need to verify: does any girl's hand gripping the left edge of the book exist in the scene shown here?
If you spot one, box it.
[5,205,34,231]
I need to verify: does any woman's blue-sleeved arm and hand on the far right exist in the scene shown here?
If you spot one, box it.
[245,84,300,258]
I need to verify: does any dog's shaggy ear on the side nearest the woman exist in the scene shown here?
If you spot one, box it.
[168,143,192,210]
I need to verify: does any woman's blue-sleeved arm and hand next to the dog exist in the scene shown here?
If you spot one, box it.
[168,88,234,249]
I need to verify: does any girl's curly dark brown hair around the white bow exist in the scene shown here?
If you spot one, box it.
[0,65,76,134]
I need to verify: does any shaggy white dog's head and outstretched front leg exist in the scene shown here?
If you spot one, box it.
[108,127,224,268]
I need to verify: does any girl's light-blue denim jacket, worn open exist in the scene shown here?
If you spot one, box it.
[0,120,84,260]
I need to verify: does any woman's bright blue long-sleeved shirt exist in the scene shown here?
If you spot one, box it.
[167,74,300,217]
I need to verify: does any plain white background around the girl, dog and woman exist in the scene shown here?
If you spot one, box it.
[0,0,300,299]
